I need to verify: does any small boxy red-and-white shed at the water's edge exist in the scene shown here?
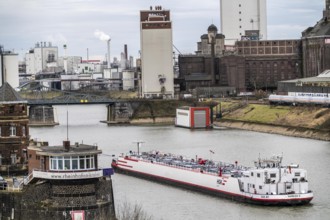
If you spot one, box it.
[175,106,211,128]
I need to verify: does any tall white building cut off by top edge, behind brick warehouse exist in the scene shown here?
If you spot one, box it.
[220,0,267,45]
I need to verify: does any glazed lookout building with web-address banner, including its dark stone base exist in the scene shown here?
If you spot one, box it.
[0,140,117,220]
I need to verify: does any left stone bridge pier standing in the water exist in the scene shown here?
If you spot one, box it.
[29,105,59,127]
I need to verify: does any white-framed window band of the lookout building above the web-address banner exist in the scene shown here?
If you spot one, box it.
[50,155,95,170]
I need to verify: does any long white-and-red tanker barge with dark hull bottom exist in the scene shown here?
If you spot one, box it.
[112,151,313,205]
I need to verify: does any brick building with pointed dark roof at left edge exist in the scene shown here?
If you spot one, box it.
[0,82,30,174]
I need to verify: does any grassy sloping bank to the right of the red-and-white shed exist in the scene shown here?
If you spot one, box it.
[214,103,330,141]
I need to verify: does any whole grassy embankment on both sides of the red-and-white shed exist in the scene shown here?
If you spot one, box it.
[109,100,330,141]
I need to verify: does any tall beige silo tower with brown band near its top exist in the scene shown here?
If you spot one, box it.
[140,6,174,98]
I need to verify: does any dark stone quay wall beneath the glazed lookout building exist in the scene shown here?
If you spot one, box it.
[0,178,116,220]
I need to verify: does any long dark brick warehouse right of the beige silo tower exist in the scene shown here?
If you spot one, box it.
[179,36,302,93]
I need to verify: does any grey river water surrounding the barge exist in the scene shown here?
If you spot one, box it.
[30,105,330,220]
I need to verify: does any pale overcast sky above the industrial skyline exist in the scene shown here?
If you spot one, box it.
[0,0,325,59]
